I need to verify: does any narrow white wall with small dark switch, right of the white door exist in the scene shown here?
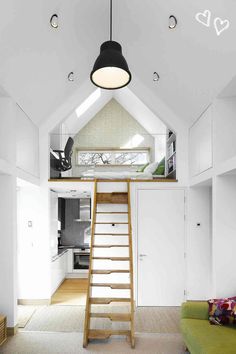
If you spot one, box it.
[186,186,212,300]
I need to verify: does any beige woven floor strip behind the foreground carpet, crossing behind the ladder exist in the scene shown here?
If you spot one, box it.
[24,305,180,333]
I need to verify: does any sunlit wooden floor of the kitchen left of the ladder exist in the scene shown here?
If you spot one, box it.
[51,279,88,305]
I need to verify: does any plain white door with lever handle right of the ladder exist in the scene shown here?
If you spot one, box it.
[138,190,185,306]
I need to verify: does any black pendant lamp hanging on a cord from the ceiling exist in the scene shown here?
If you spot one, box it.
[90,0,131,90]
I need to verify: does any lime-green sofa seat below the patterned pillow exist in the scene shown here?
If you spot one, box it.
[181,318,236,354]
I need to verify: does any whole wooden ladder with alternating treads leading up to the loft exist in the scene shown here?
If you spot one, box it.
[83,181,135,348]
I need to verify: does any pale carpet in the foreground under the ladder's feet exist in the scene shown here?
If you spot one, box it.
[0,332,184,354]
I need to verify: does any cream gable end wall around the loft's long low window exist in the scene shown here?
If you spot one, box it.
[72,99,155,176]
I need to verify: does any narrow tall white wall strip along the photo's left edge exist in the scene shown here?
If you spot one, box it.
[0,97,17,327]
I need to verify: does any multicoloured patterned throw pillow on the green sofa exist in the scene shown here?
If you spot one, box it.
[208,296,236,325]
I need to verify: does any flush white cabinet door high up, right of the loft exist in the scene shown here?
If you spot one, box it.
[189,107,212,177]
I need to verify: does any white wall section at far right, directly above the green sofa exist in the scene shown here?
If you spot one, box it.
[213,175,236,297]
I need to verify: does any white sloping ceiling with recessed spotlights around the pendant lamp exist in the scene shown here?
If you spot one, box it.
[0,0,236,125]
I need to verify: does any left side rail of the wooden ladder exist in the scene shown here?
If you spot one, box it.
[83,179,97,348]
